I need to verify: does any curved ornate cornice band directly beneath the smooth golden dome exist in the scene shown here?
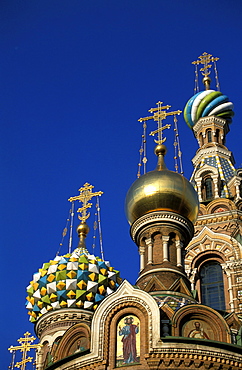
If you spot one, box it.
[130,211,194,244]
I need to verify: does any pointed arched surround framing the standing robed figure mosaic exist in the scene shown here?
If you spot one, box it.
[91,280,160,370]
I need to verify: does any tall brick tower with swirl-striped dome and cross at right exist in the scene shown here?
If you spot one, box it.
[184,53,242,313]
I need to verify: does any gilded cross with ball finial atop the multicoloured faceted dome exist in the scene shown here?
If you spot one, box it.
[68,182,103,248]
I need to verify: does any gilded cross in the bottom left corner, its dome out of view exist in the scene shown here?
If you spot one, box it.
[8,331,42,370]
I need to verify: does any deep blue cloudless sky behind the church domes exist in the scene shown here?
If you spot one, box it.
[0,0,242,369]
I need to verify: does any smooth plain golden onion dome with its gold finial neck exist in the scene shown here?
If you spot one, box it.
[125,144,199,224]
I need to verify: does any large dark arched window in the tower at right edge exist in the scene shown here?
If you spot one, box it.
[200,261,225,310]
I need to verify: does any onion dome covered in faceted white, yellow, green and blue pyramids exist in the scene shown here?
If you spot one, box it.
[26,248,122,322]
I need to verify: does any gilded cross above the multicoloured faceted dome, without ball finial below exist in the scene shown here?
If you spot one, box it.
[68,182,103,223]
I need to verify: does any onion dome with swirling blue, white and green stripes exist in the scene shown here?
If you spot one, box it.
[184,90,234,129]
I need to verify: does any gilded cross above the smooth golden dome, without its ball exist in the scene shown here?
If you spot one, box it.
[138,101,182,144]
